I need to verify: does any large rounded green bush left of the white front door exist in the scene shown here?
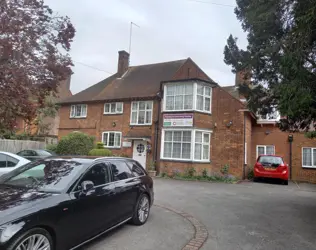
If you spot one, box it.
[56,132,94,155]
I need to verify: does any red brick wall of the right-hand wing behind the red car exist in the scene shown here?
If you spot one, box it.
[251,125,316,183]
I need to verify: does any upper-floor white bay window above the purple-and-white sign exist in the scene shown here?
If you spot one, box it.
[164,82,212,113]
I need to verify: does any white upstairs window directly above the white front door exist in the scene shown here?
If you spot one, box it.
[130,101,153,125]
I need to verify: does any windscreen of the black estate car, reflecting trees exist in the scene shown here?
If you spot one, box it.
[0,160,85,193]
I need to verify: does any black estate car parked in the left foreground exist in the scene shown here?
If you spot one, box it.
[0,157,154,250]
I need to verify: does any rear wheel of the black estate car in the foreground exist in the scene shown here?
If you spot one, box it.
[131,194,150,226]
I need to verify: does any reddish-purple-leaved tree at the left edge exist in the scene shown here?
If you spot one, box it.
[0,0,75,130]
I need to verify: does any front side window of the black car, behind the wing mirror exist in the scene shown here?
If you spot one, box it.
[79,163,110,186]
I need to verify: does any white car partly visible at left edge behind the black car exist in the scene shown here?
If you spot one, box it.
[0,151,30,176]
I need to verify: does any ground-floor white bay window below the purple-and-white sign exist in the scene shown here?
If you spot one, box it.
[161,129,211,161]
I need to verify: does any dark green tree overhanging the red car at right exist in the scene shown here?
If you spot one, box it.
[224,0,316,135]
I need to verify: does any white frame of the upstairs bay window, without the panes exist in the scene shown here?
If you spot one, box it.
[162,82,213,114]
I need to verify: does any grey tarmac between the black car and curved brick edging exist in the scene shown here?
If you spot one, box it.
[82,206,194,250]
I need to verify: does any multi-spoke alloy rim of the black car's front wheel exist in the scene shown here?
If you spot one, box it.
[16,234,51,250]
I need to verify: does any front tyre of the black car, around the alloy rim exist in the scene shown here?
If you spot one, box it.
[7,228,55,250]
